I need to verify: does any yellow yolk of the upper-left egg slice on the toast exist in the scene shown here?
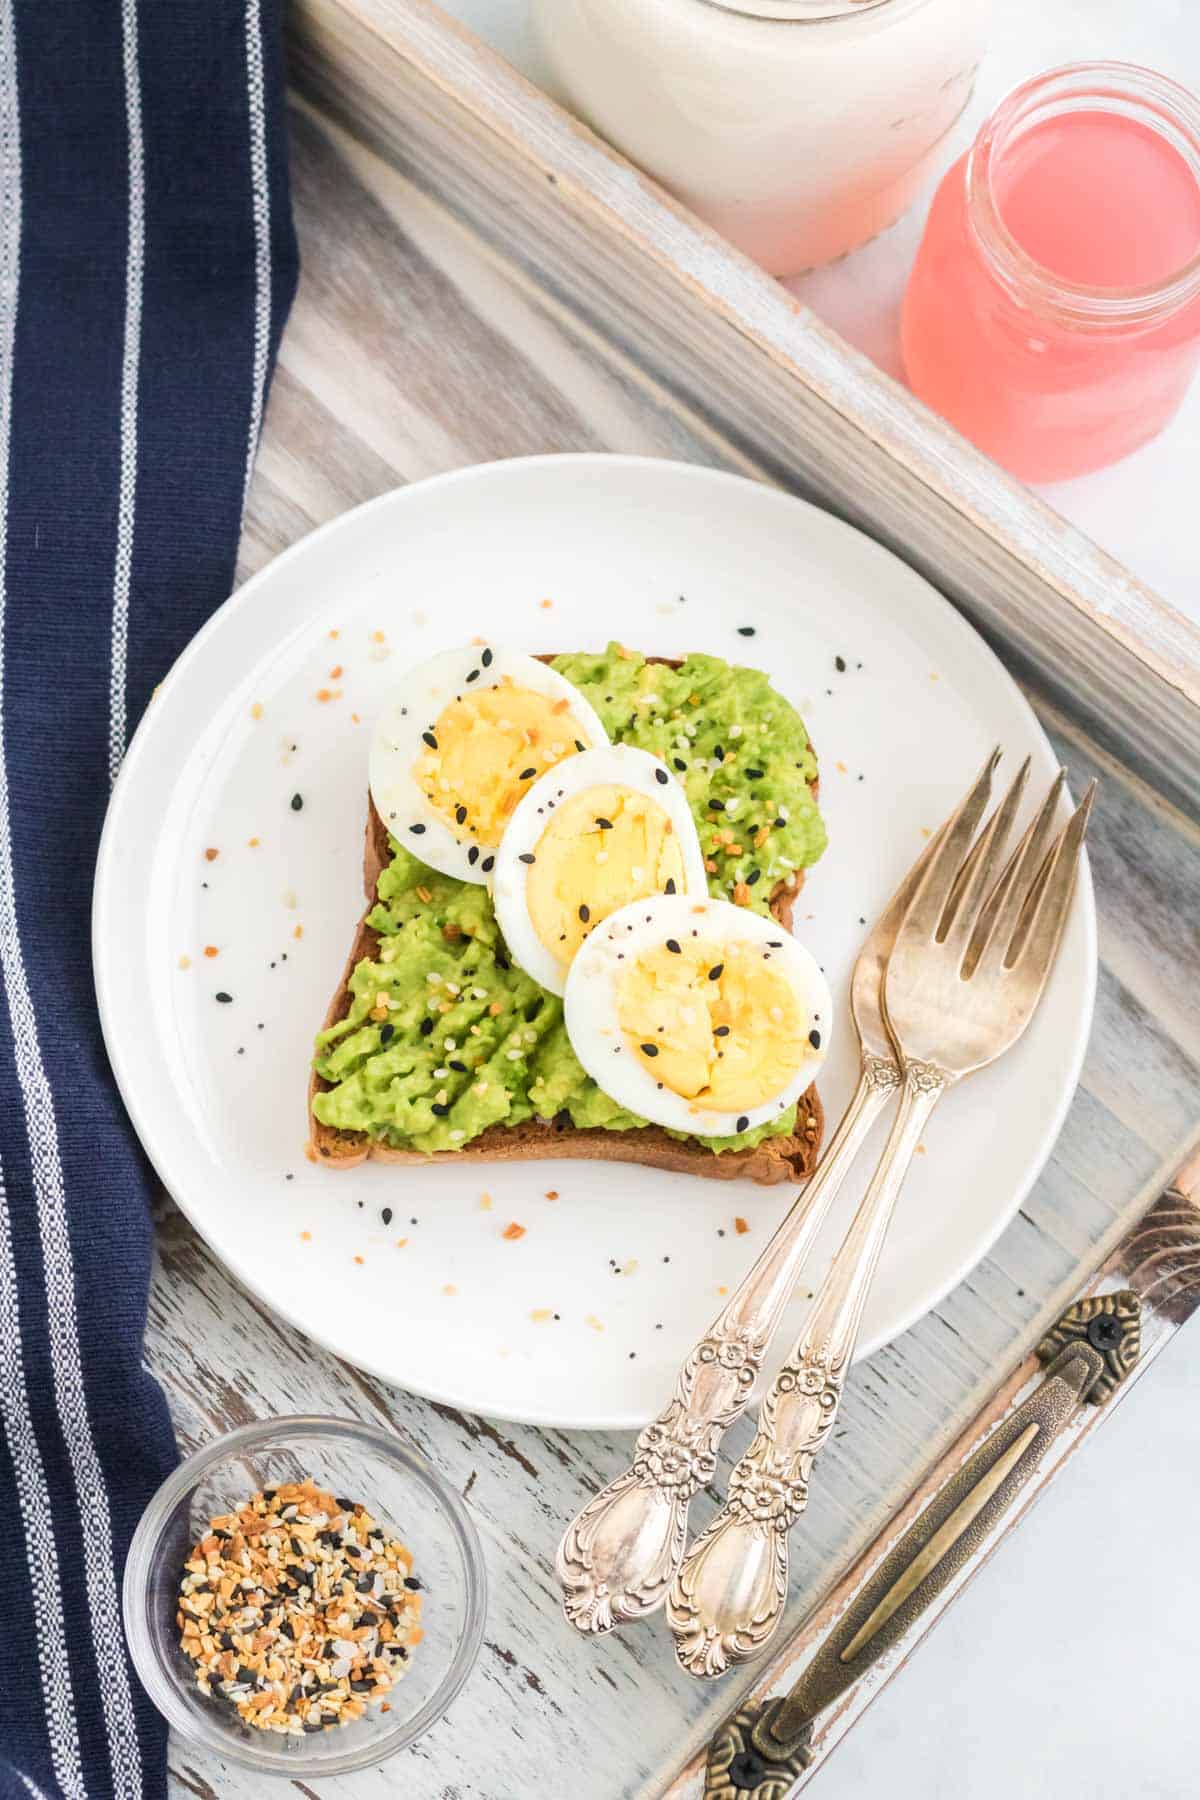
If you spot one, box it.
[412,679,587,844]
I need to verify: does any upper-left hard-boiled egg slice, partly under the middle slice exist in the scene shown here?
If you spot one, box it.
[371,644,608,882]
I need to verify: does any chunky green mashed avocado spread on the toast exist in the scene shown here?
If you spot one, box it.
[313,644,826,1152]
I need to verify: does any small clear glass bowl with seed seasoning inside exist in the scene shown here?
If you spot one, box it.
[124,1417,488,1778]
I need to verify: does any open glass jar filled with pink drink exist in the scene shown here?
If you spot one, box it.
[901,63,1200,481]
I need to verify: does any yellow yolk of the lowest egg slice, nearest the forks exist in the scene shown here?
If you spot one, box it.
[617,938,811,1112]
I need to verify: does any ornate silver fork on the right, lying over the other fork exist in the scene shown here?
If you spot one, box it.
[667,758,1096,1676]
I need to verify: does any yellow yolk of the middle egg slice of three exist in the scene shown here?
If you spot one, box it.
[525,787,684,963]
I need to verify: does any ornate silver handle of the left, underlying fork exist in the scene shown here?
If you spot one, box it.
[554,1057,901,1633]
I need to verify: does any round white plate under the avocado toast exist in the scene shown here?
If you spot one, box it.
[95,455,1096,1427]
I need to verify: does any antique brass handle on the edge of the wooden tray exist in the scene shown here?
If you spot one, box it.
[703,1289,1141,1800]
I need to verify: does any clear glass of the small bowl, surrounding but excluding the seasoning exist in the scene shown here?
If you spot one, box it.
[122,1418,488,1778]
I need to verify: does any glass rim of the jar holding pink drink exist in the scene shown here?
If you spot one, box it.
[966,61,1200,328]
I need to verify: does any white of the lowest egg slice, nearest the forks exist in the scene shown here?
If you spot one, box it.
[563,895,833,1138]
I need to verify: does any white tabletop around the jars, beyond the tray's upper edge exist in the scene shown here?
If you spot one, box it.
[443,0,1200,619]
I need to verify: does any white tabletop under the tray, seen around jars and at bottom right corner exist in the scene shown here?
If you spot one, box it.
[415,0,1200,1800]
